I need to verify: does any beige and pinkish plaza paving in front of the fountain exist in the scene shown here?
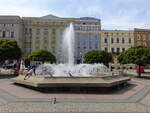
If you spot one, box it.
[0,75,150,113]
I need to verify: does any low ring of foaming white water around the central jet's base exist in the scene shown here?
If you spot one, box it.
[36,63,109,77]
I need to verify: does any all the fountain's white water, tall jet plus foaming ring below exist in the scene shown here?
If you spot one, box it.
[36,23,109,77]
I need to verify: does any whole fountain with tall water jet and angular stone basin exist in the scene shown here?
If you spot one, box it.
[12,23,130,87]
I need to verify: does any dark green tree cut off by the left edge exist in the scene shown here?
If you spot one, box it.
[0,39,22,62]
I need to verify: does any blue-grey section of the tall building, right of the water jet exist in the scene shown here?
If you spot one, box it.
[74,17,101,63]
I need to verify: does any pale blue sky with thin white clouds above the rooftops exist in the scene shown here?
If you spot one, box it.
[0,0,150,30]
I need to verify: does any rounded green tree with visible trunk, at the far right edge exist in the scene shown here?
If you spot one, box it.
[117,46,150,77]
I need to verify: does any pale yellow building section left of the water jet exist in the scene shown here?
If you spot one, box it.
[22,15,68,59]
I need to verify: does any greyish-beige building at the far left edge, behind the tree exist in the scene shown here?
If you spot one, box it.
[0,16,23,50]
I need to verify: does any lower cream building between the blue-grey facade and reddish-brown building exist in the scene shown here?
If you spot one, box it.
[100,30,134,53]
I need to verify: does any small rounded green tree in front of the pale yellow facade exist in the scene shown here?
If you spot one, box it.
[29,50,56,63]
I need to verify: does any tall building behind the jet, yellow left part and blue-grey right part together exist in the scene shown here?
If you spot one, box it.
[22,15,101,63]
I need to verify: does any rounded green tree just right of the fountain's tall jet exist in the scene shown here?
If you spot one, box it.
[83,50,113,66]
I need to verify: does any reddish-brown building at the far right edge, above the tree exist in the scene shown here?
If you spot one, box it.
[134,28,150,46]
